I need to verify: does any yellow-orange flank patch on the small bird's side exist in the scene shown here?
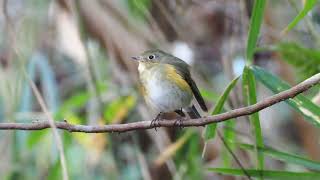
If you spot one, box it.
[165,65,192,94]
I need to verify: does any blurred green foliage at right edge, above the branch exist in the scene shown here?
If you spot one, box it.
[272,43,320,79]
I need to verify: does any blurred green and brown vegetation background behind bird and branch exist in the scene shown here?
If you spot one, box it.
[0,0,320,180]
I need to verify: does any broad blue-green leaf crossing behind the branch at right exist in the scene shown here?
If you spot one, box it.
[252,66,320,127]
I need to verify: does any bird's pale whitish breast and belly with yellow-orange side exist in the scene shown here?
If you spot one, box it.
[138,64,193,112]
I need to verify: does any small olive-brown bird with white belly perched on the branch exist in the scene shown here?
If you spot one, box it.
[132,50,208,125]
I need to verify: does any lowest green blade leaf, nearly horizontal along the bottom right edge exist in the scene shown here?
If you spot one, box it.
[208,168,320,180]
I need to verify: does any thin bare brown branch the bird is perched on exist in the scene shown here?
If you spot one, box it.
[0,73,320,133]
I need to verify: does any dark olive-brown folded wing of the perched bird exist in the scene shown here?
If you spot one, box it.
[165,57,208,111]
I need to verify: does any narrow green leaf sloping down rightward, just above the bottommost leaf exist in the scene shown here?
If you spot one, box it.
[236,143,320,170]
